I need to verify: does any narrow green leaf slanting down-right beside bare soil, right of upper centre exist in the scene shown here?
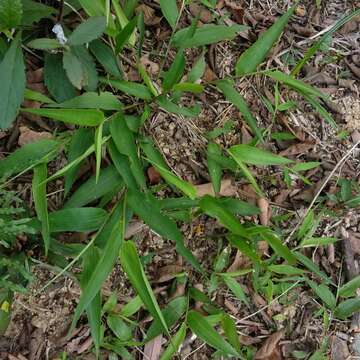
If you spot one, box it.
[216,80,263,140]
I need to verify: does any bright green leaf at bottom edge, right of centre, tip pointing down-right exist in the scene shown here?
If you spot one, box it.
[187,310,239,357]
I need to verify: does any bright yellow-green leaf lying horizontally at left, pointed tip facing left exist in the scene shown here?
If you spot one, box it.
[21,108,104,126]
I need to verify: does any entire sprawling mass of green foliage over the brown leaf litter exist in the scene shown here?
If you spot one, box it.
[0,0,360,359]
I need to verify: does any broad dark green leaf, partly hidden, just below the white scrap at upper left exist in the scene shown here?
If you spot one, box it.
[44,53,76,102]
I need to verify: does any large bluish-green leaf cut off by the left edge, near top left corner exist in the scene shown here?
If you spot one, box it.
[0,35,25,129]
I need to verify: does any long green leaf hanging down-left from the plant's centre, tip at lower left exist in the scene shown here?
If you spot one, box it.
[69,201,128,334]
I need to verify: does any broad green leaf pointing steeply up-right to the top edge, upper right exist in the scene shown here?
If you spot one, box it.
[235,7,295,76]
